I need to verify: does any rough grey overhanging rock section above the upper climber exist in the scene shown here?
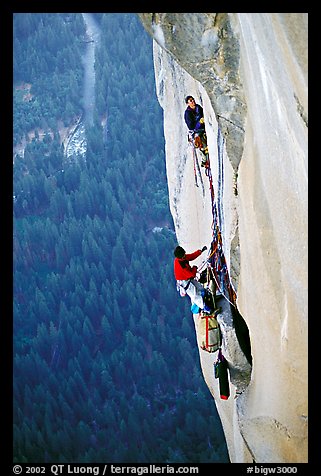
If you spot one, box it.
[140,13,246,173]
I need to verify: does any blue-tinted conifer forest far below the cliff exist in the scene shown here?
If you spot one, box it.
[13,13,229,463]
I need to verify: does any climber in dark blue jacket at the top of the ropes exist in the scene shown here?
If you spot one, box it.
[184,96,208,167]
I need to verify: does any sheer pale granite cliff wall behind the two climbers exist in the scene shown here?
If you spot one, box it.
[139,13,308,463]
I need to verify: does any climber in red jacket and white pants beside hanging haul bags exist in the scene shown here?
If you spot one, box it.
[174,246,210,312]
